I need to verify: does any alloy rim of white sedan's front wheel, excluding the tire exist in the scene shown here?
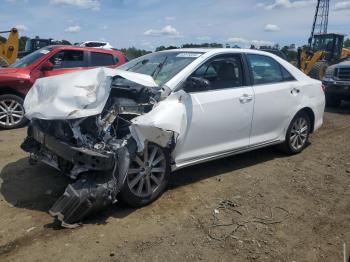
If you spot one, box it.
[127,144,166,197]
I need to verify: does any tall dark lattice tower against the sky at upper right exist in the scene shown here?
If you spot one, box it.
[309,0,329,47]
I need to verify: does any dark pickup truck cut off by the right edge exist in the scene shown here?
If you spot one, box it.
[323,61,350,107]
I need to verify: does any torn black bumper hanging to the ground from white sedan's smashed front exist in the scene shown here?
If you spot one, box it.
[22,126,130,228]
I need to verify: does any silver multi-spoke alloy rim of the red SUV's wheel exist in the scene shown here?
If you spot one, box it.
[0,99,24,127]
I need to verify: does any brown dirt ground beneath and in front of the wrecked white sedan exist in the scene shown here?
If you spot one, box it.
[0,104,350,262]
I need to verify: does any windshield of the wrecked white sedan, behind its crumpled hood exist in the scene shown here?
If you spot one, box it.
[119,51,203,85]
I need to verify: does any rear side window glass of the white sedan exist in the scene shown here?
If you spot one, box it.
[247,54,294,85]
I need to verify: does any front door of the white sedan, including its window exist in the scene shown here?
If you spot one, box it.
[175,54,254,164]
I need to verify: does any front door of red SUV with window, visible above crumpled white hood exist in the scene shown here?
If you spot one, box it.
[43,50,88,77]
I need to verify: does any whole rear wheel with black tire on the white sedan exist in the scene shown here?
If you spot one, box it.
[280,112,311,155]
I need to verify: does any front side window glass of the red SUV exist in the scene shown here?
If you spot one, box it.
[49,50,87,69]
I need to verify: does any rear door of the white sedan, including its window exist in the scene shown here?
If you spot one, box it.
[247,54,303,146]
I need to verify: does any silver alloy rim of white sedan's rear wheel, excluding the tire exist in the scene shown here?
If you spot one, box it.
[289,117,309,151]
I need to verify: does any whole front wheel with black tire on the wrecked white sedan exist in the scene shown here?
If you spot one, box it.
[120,143,170,207]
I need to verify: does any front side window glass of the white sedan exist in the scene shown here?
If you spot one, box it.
[191,55,244,92]
